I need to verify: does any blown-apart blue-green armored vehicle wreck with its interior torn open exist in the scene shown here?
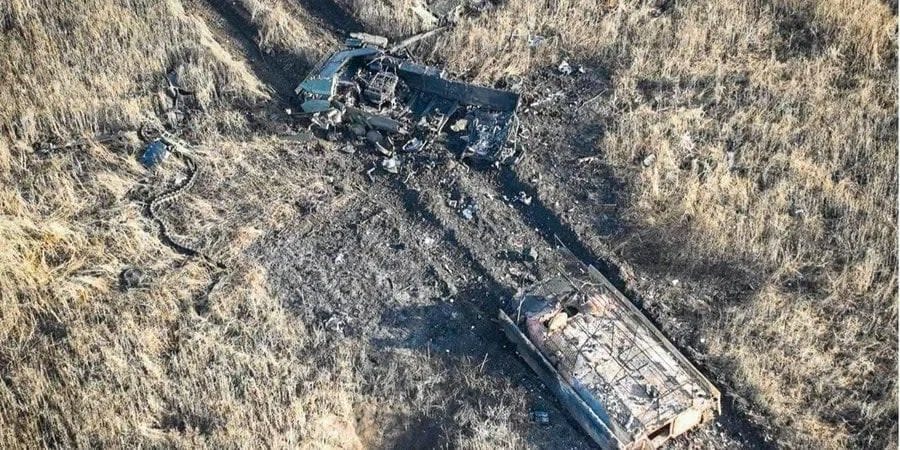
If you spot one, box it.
[295,30,519,162]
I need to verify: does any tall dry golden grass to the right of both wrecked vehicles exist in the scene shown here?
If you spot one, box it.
[436,0,897,448]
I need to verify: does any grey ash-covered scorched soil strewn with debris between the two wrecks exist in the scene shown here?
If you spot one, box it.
[241,83,768,448]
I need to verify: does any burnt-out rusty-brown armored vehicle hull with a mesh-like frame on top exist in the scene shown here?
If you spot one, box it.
[500,251,721,449]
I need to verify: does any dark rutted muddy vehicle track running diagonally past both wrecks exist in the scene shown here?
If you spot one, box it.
[195,0,765,445]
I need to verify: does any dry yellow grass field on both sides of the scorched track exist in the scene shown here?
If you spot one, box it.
[0,0,898,448]
